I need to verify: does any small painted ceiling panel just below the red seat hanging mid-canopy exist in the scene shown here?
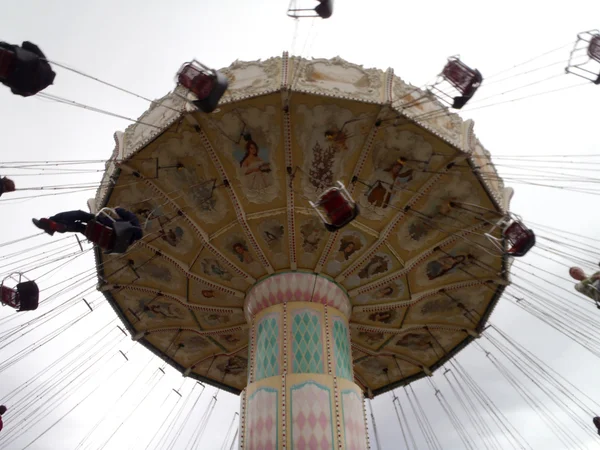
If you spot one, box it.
[324,224,378,282]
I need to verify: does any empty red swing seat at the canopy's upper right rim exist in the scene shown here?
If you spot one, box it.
[433,56,483,109]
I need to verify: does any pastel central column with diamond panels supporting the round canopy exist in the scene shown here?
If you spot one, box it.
[240,272,369,450]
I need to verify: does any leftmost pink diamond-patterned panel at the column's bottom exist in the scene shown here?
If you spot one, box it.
[246,388,279,450]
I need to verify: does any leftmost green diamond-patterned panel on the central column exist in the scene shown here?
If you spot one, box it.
[255,315,279,381]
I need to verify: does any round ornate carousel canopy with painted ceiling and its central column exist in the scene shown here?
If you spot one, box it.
[89,47,534,448]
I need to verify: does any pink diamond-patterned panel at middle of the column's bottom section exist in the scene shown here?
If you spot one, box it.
[290,381,332,450]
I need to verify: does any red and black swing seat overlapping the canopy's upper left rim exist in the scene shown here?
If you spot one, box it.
[177,61,228,113]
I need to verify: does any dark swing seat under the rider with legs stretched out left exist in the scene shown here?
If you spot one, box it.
[85,208,135,255]
